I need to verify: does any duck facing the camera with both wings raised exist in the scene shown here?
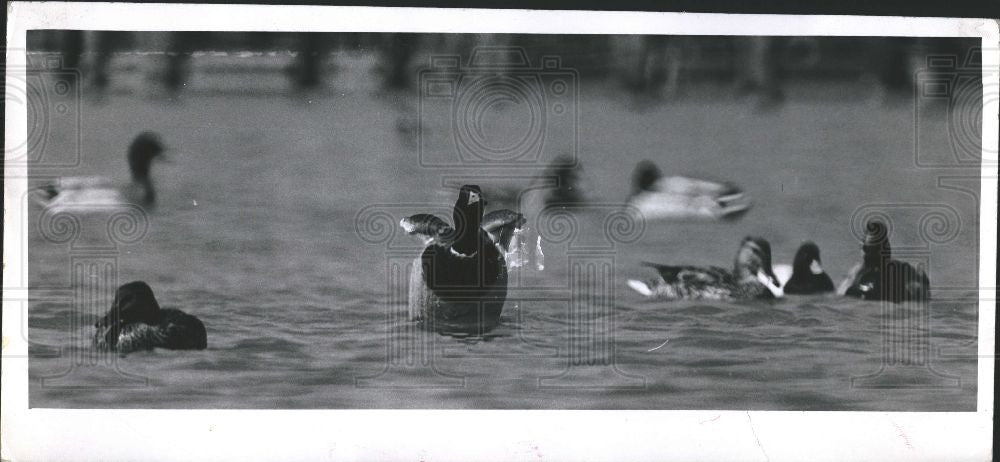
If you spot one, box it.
[400,185,524,333]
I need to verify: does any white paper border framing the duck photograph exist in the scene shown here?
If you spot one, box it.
[0,2,1000,461]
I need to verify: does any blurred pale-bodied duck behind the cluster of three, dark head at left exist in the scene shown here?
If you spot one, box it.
[628,160,752,220]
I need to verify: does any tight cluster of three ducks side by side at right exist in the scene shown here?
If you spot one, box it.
[628,221,930,303]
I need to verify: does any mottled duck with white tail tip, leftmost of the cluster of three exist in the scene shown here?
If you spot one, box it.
[628,236,783,300]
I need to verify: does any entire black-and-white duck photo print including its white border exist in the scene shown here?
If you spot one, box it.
[3,3,998,460]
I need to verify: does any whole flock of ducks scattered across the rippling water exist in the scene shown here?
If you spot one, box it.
[32,132,930,353]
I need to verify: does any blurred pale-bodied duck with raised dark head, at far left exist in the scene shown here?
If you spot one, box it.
[32,132,165,211]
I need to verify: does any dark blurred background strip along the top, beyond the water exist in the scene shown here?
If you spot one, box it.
[28,31,969,103]
